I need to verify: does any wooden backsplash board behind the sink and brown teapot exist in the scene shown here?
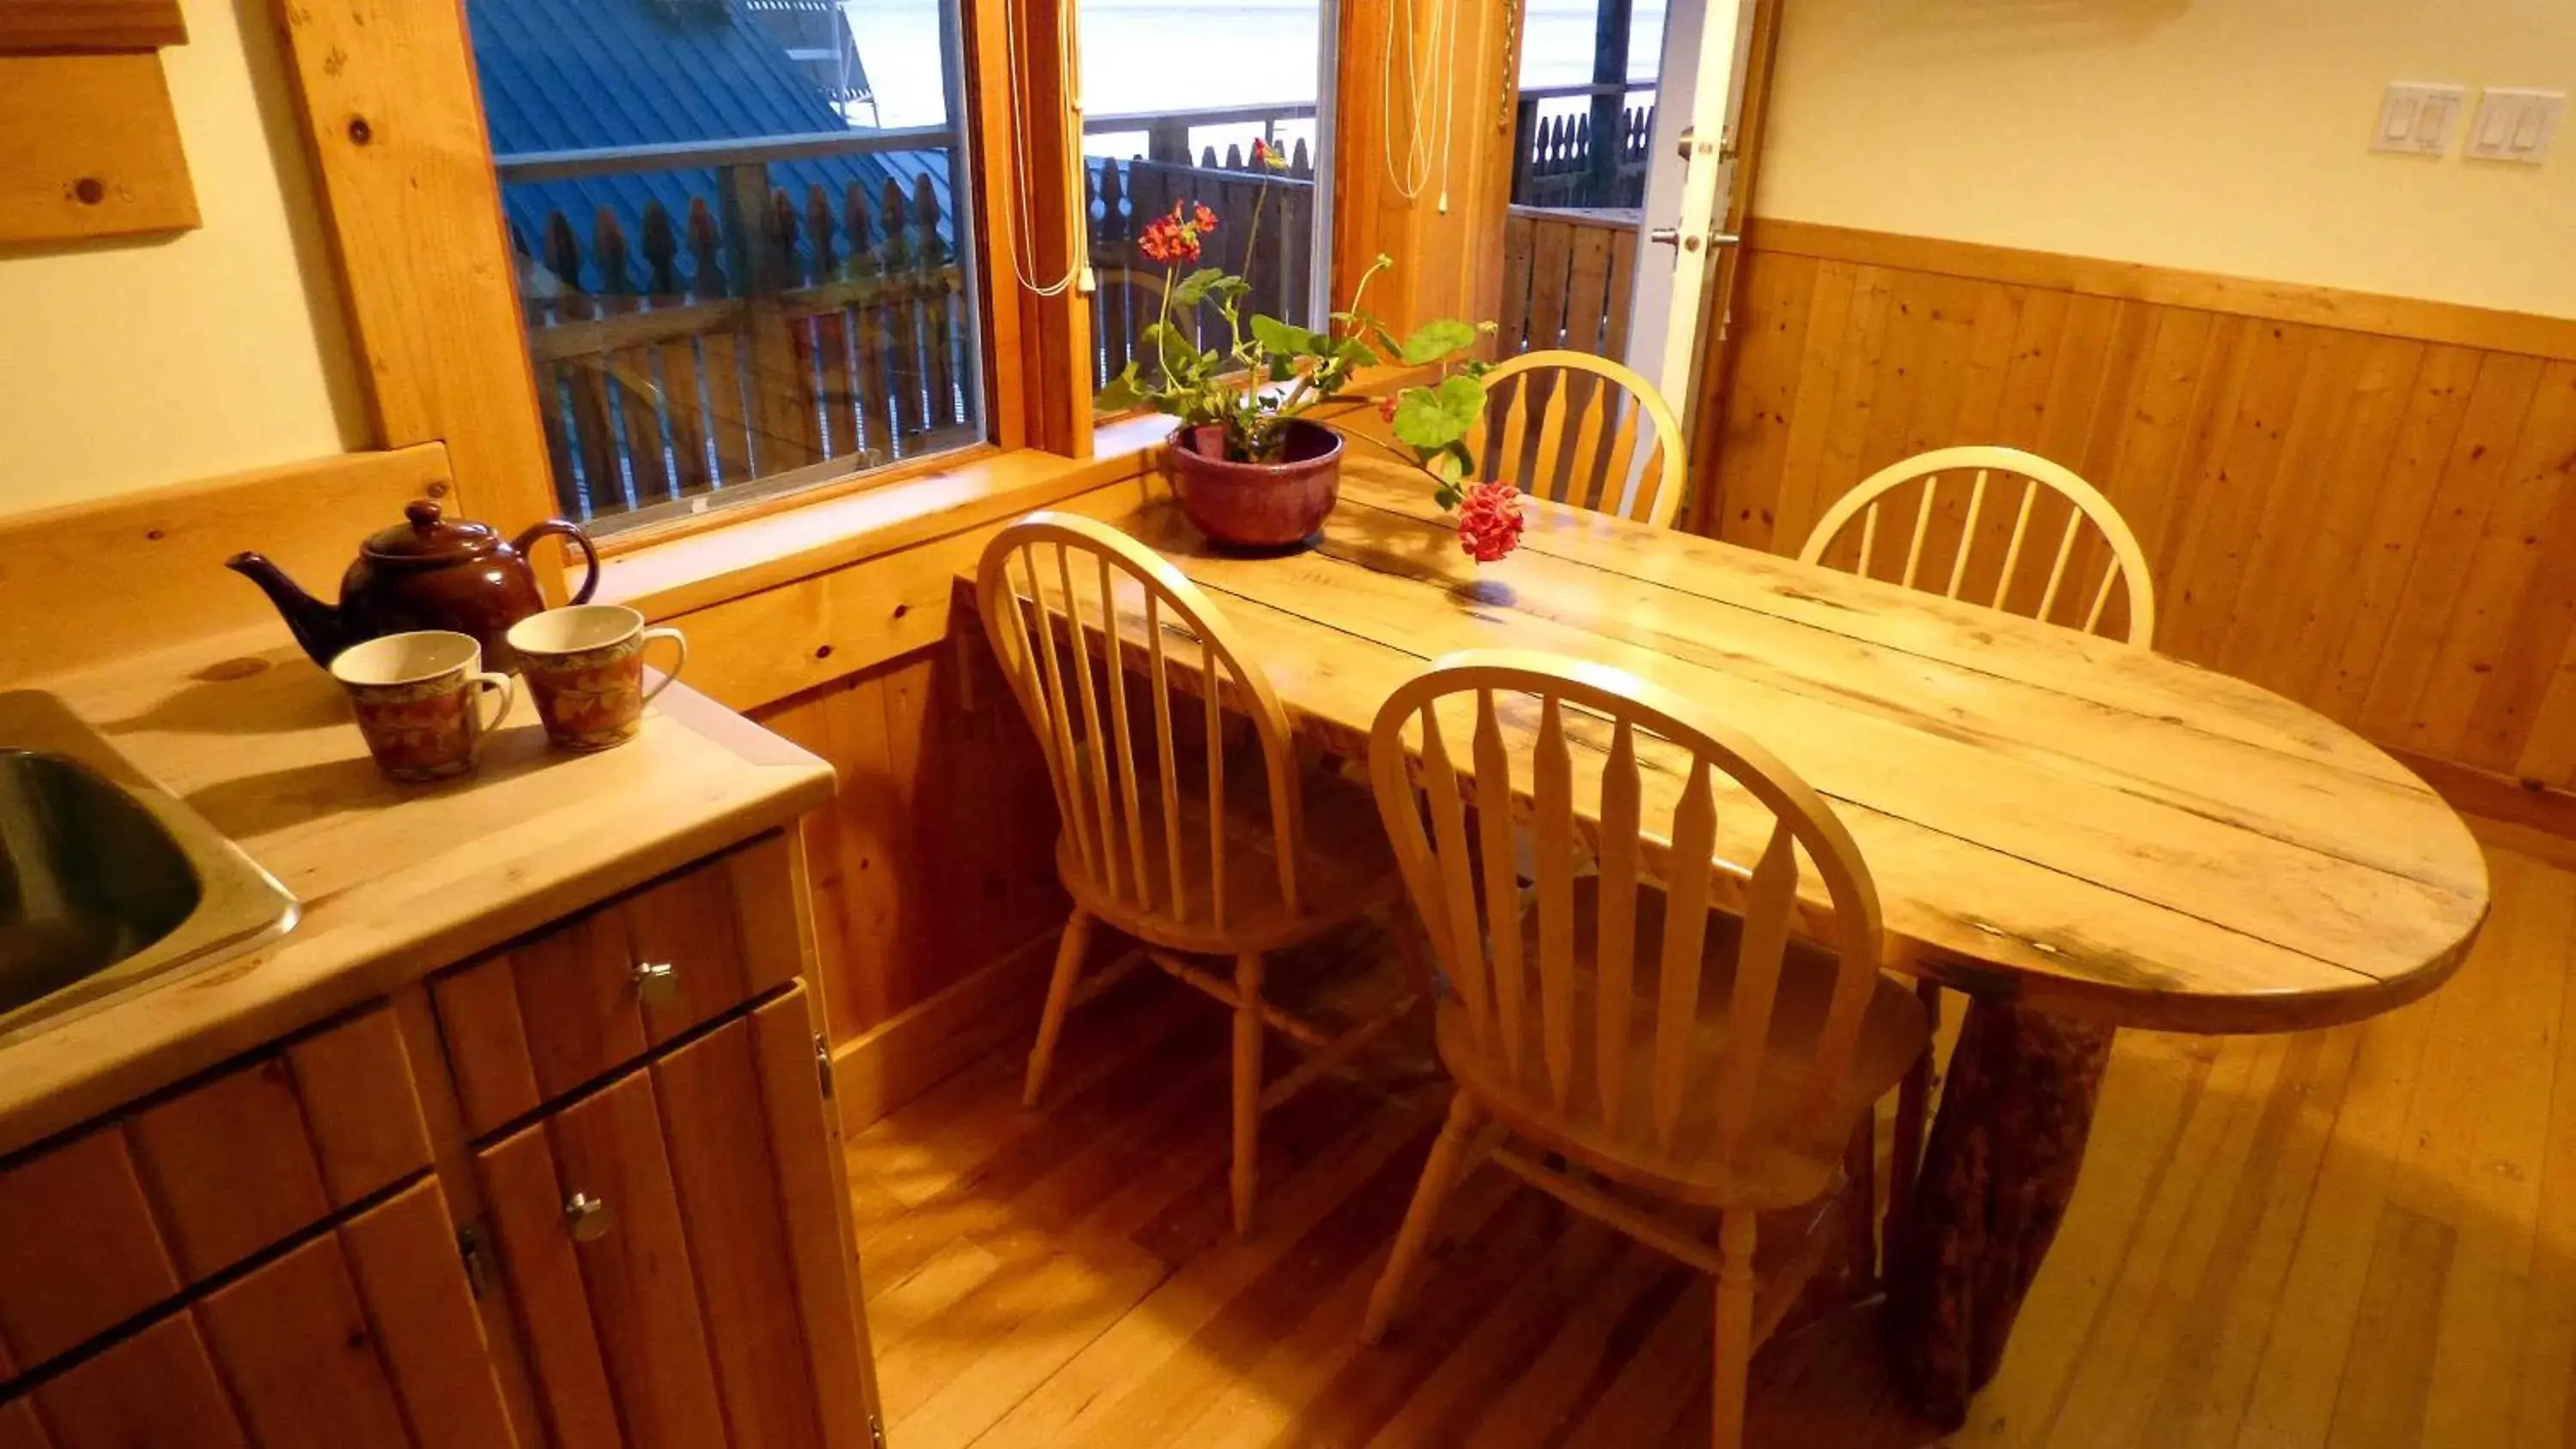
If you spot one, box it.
[0,443,448,685]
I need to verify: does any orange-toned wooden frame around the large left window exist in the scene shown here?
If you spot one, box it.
[273,0,1092,561]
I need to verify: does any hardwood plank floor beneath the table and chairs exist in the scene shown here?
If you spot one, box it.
[850,828,2576,1449]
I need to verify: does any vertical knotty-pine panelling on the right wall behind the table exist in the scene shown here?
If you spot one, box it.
[1695,224,2576,785]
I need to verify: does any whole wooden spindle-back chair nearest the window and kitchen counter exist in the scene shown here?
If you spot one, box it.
[976,512,1422,1233]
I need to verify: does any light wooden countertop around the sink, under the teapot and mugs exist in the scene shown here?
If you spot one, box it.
[0,626,832,1153]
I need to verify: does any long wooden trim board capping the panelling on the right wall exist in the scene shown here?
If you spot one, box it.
[1744,216,2576,361]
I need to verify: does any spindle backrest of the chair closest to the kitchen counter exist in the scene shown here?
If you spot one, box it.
[976,512,1301,929]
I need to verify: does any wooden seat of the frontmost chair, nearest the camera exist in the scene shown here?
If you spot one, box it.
[1437,875,1929,1212]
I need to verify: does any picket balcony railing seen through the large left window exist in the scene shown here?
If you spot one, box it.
[497,129,981,532]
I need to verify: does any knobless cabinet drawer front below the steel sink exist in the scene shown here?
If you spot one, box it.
[0,1009,430,1369]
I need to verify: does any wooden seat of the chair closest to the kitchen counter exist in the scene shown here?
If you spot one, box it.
[1056,769,1401,955]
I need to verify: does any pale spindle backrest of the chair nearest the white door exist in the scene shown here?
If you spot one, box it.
[1473,353,1685,528]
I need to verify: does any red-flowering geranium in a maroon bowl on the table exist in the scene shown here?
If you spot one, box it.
[1097,142,1520,564]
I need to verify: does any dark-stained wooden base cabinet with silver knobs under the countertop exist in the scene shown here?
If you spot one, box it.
[0,834,876,1449]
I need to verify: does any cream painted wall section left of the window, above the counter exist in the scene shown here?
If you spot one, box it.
[0,0,366,515]
